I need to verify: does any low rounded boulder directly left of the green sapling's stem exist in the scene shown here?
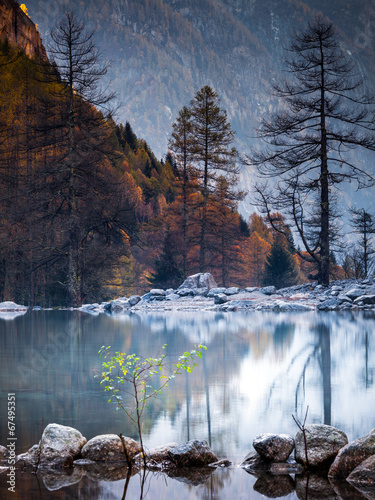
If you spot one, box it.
[82,434,141,462]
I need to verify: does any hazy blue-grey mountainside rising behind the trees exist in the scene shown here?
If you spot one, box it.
[26,0,375,221]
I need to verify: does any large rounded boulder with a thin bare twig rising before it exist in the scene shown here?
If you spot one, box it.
[294,424,348,468]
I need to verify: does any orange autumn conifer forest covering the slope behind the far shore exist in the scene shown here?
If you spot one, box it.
[0,14,373,307]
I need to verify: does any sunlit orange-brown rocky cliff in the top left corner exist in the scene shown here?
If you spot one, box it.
[0,0,47,60]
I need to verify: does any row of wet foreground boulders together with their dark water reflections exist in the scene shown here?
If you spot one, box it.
[0,424,375,500]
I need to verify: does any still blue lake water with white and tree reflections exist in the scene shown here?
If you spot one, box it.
[0,311,375,500]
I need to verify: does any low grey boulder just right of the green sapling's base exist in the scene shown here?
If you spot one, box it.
[168,440,218,467]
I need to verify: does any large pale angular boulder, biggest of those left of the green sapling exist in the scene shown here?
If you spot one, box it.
[34,424,87,468]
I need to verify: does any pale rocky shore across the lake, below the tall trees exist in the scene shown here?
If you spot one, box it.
[80,273,375,314]
